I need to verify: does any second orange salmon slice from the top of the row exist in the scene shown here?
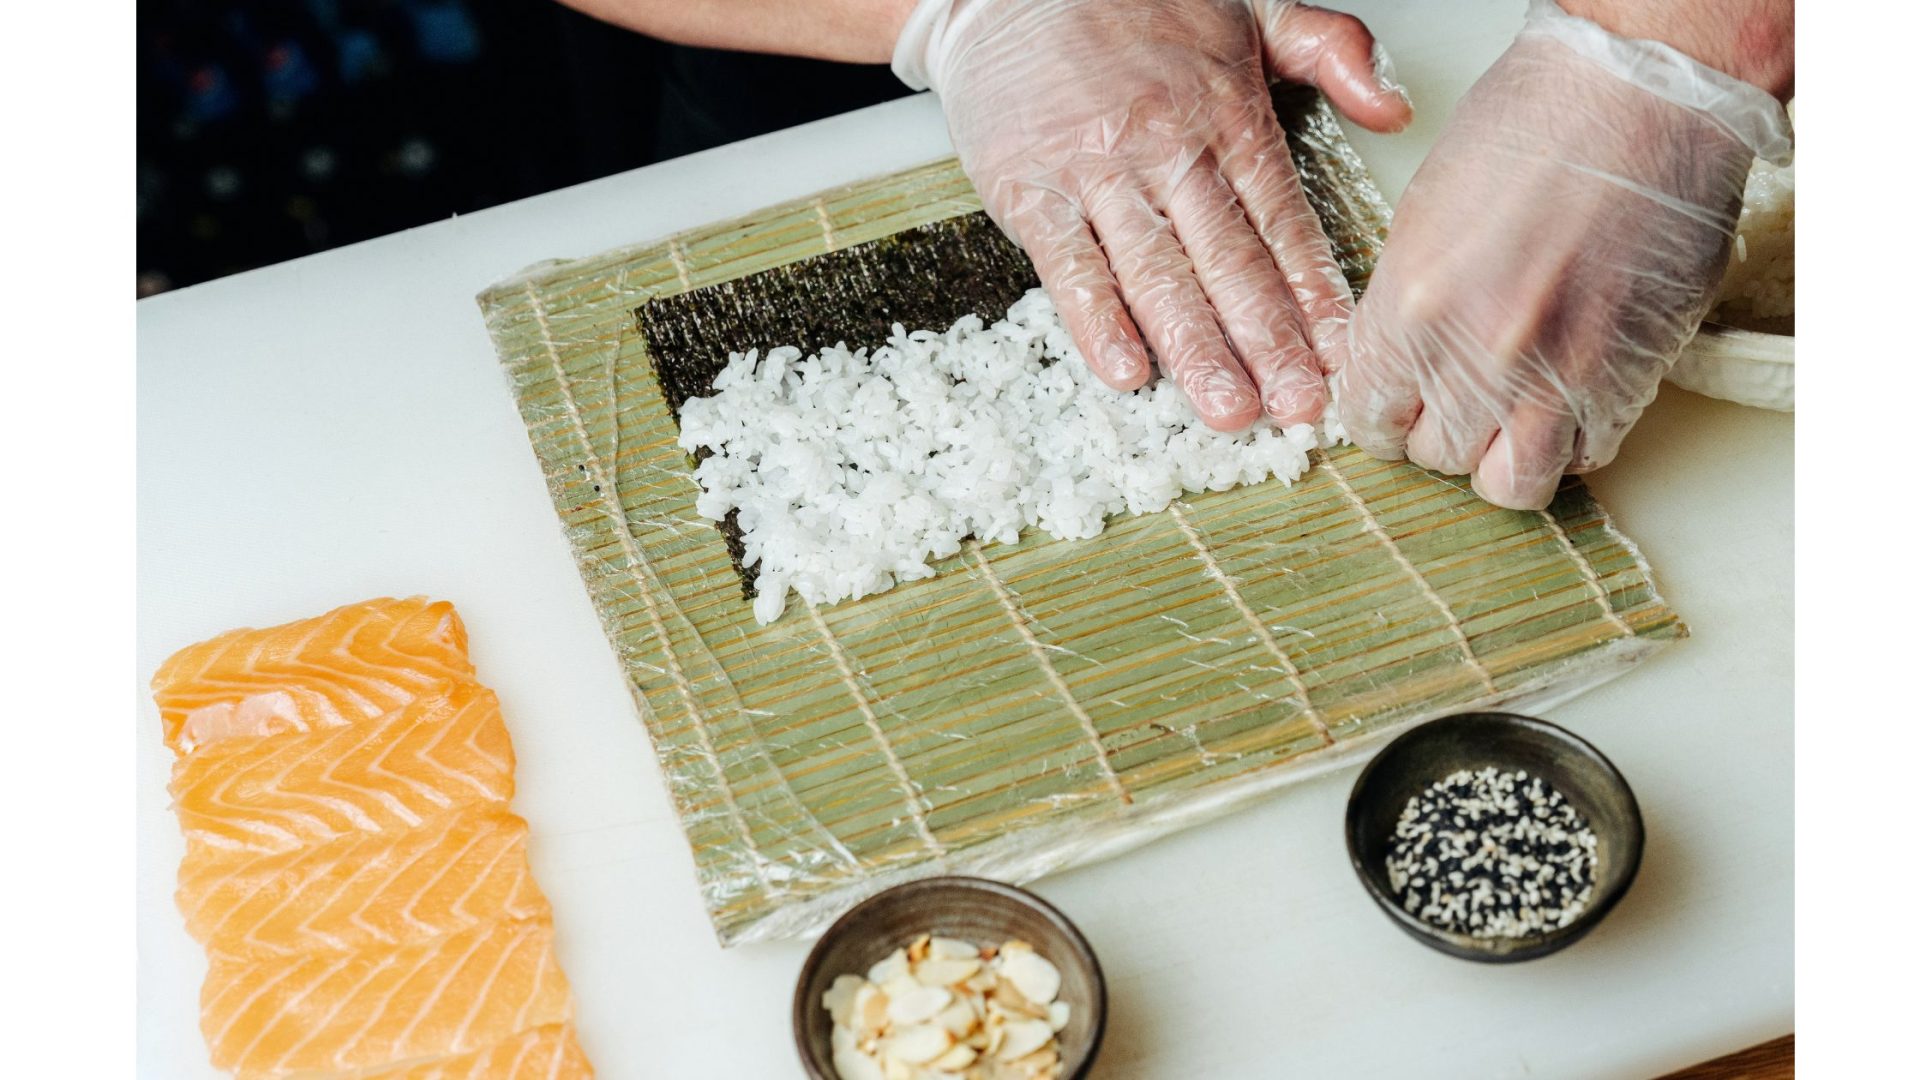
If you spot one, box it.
[169,682,513,857]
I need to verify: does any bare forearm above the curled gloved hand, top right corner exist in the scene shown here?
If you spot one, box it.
[1561,0,1793,102]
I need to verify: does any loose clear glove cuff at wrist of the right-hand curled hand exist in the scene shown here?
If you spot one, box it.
[1521,0,1793,165]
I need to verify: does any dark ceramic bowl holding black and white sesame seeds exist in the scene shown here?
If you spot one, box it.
[1346,713,1645,963]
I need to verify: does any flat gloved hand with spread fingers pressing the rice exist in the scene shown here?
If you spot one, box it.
[893,0,1413,430]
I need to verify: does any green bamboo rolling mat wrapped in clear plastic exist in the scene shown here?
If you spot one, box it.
[480,94,1686,944]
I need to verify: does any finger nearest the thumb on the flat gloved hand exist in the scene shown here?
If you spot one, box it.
[1215,98,1354,373]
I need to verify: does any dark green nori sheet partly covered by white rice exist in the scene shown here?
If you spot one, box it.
[634,86,1384,601]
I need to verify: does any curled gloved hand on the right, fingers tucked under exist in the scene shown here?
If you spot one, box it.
[1334,0,1791,509]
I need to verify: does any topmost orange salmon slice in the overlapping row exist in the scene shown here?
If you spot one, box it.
[154,596,472,753]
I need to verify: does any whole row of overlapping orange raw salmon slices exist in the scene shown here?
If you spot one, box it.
[154,600,593,1080]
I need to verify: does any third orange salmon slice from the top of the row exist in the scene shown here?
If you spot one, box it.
[177,803,551,959]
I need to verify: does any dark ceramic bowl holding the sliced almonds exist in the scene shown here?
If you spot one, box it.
[793,878,1106,1080]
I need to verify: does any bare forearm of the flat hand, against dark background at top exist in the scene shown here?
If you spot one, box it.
[561,0,914,63]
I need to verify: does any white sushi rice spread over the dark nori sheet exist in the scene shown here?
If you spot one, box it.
[680,288,1340,625]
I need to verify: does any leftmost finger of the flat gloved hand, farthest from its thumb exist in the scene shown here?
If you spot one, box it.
[1010,192,1150,390]
